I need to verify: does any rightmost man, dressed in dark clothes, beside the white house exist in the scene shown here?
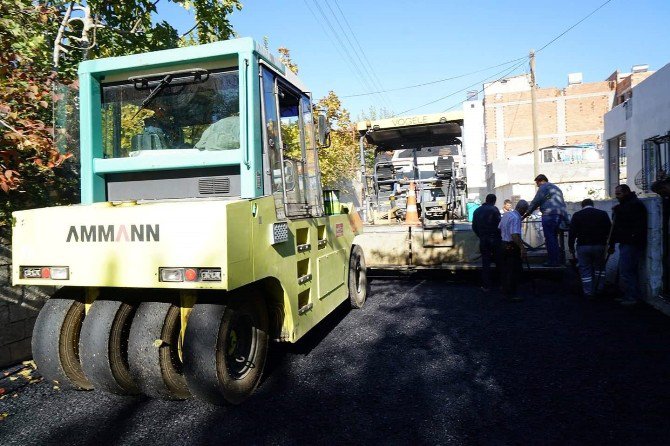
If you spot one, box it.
[609,184,647,305]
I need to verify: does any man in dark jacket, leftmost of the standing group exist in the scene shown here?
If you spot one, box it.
[472,194,501,291]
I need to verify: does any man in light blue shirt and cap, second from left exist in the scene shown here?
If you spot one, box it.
[499,200,528,301]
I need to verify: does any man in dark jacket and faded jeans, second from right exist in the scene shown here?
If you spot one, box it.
[568,198,612,299]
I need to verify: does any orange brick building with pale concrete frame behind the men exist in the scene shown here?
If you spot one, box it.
[484,71,649,201]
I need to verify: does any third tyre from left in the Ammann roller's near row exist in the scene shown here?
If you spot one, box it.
[128,302,190,399]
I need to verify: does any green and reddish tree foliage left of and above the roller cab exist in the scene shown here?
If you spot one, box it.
[0,0,242,230]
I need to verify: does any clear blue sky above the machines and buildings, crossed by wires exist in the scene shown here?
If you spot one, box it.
[158,0,670,120]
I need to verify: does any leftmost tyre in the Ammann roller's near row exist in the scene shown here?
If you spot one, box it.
[32,297,93,390]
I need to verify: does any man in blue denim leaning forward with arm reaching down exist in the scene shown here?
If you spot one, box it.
[524,174,568,267]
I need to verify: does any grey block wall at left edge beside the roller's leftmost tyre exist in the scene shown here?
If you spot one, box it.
[0,239,55,368]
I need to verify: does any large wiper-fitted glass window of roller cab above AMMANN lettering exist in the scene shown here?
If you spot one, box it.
[102,71,240,158]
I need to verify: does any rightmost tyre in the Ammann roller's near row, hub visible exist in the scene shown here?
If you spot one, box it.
[184,296,268,405]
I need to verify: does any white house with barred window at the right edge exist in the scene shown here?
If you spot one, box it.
[603,64,670,308]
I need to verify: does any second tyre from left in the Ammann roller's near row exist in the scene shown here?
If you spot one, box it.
[79,300,139,395]
